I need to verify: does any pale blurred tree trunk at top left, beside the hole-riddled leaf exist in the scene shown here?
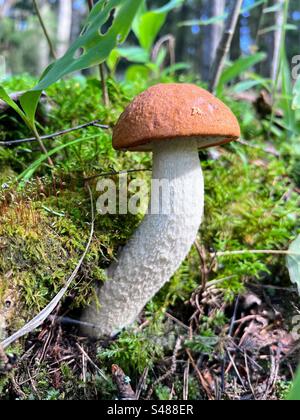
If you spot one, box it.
[57,0,72,57]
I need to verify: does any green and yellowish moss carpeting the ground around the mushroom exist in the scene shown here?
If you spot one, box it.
[0,78,300,399]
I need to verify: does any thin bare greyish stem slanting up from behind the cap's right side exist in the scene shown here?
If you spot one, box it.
[209,0,243,92]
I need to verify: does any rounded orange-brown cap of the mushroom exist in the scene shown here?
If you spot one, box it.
[113,83,241,151]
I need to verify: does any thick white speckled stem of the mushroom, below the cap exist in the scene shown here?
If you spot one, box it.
[84,139,204,337]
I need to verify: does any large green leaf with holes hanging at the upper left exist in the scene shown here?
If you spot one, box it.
[21,0,143,124]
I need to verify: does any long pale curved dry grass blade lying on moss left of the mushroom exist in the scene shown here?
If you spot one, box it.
[0,186,95,349]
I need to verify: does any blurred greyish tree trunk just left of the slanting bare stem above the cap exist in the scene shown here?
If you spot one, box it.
[201,0,225,81]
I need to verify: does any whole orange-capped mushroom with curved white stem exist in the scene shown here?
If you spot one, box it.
[83,83,240,337]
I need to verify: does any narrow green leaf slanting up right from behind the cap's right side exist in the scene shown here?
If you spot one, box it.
[217,53,266,93]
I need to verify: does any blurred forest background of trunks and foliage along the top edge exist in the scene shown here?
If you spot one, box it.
[0,0,300,81]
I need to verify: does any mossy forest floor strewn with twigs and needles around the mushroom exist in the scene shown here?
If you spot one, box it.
[0,77,300,400]
